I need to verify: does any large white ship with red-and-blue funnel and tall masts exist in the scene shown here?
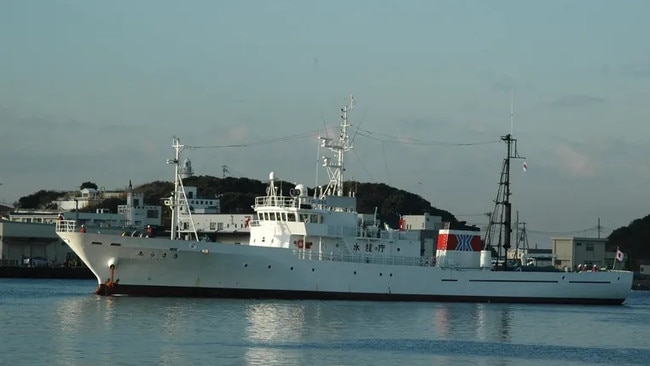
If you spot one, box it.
[56,99,632,304]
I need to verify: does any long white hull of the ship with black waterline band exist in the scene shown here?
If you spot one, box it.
[59,232,632,305]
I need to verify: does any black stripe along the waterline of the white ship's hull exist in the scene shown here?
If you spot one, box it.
[97,285,625,305]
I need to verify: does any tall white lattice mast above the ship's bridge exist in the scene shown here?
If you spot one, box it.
[320,95,354,198]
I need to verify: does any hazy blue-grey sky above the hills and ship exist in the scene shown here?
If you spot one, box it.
[0,0,650,247]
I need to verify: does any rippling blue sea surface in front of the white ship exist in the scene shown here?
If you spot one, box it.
[0,279,650,366]
